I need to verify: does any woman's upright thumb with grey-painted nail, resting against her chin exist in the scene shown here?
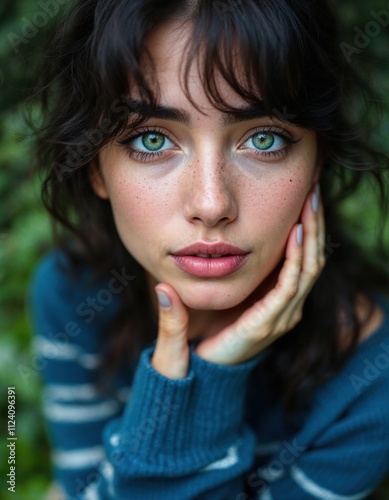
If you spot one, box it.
[151,283,189,379]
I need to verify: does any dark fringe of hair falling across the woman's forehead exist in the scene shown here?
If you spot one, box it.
[89,0,342,131]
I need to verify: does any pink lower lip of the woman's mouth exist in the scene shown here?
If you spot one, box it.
[173,254,249,278]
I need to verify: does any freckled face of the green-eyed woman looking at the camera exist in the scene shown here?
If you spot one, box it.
[91,23,319,310]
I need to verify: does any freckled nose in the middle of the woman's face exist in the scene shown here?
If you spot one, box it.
[185,157,238,227]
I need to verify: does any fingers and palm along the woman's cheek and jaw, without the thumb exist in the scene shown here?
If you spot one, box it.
[195,182,325,365]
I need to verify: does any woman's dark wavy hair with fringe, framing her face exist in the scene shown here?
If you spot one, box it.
[31,0,389,412]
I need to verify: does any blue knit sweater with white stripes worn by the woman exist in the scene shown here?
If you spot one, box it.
[29,252,389,500]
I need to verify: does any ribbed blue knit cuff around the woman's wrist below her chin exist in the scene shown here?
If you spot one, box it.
[104,345,261,477]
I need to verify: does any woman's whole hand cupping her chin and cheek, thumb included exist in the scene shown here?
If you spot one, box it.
[152,188,325,378]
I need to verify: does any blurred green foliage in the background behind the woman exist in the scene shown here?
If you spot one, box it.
[0,0,389,500]
